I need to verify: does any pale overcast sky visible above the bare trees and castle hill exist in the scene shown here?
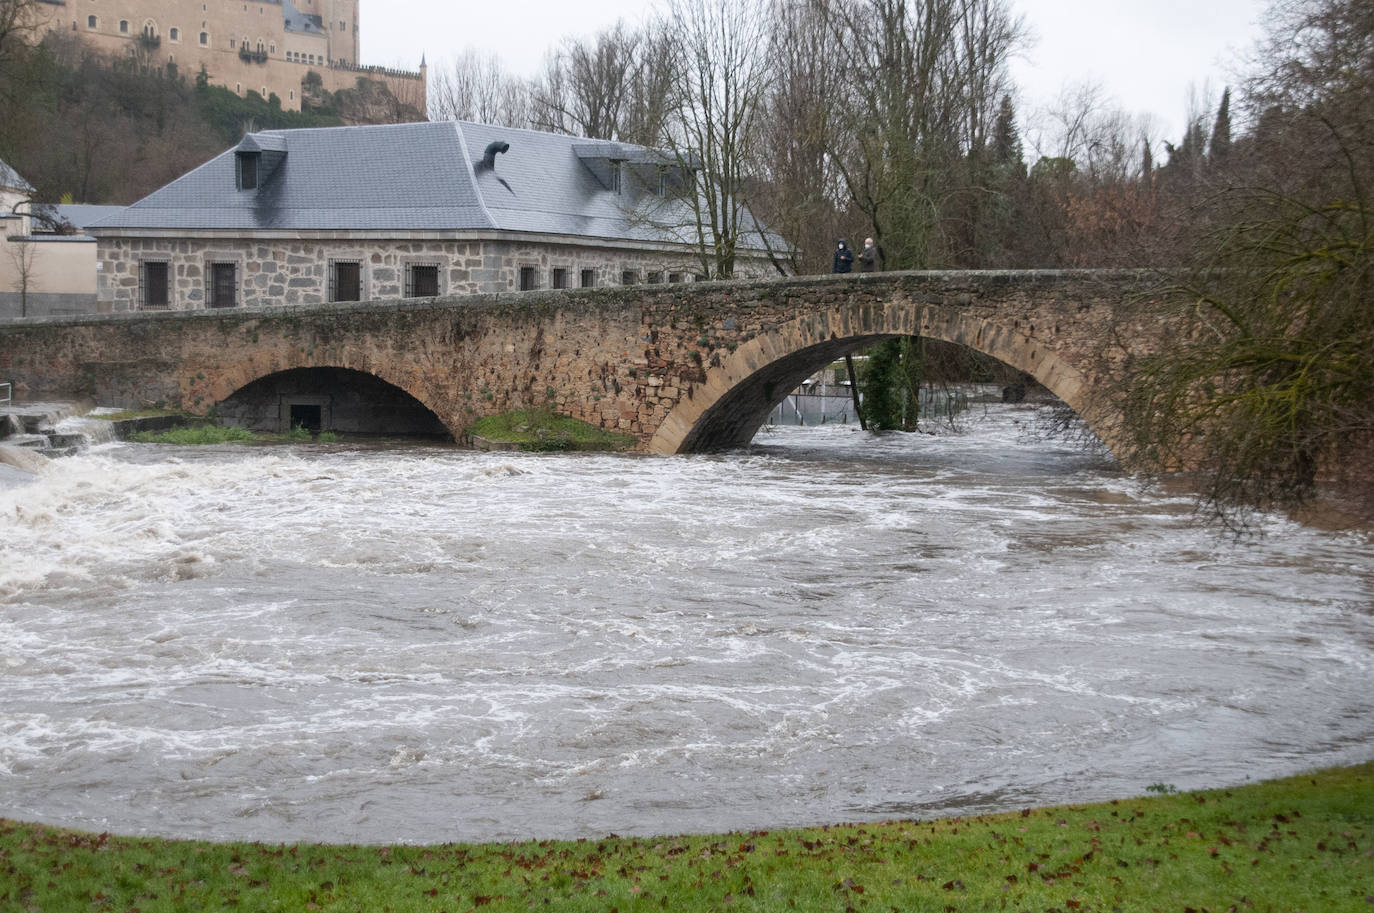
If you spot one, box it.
[360,0,1268,142]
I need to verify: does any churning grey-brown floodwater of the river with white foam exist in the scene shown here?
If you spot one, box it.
[0,406,1374,843]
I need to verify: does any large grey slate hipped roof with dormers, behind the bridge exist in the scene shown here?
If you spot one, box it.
[92,121,785,253]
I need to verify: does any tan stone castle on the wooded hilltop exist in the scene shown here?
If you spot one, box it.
[40,0,426,114]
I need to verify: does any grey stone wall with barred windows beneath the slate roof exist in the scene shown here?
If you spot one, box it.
[99,238,776,312]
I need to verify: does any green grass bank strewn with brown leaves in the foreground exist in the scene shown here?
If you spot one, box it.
[0,763,1374,913]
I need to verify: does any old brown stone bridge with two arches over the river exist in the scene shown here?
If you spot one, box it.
[0,271,1154,452]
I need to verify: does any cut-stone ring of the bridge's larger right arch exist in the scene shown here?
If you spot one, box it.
[649,303,1103,454]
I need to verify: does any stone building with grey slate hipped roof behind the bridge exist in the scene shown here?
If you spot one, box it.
[89,121,783,311]
